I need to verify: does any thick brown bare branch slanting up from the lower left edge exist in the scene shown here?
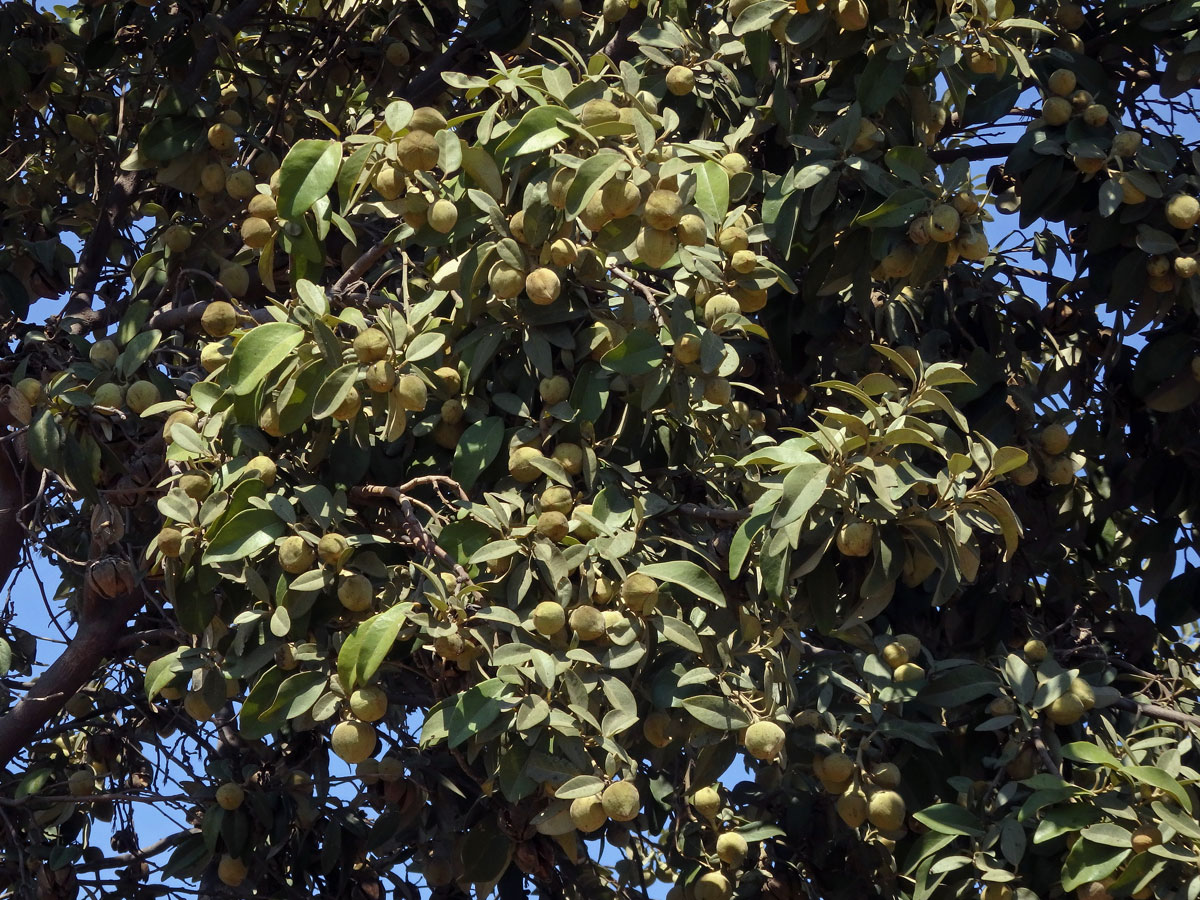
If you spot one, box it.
[0,593,142,766]
